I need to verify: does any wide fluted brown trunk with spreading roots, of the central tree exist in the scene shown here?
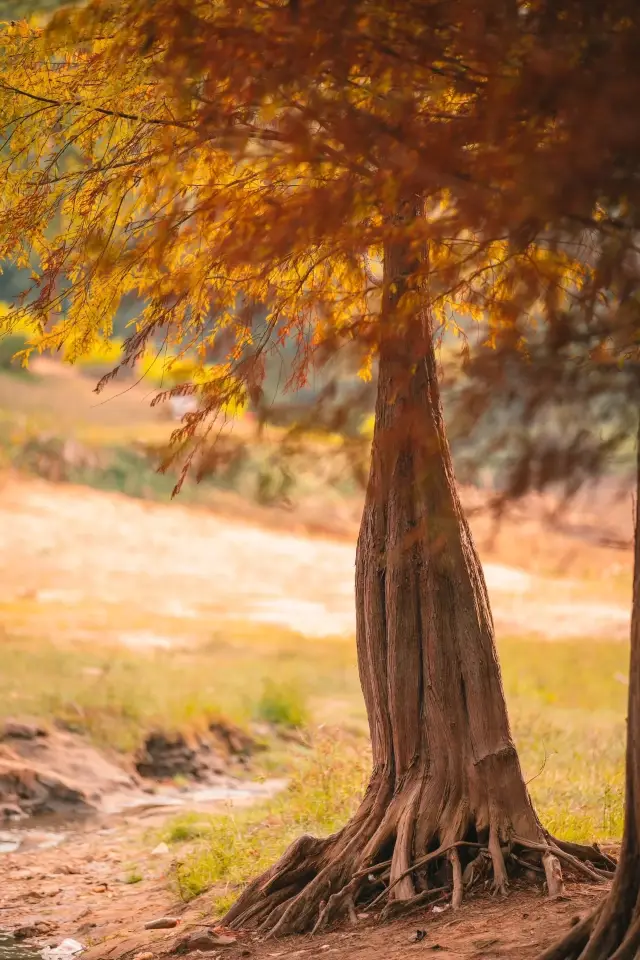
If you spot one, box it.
[224,205,606,935]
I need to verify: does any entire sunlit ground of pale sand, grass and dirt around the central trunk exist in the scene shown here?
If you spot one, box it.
[0,362,631,960]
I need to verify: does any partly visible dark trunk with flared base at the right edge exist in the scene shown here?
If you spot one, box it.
[540,414,640,960]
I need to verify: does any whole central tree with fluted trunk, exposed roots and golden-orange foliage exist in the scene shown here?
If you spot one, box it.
[0,0,612,934]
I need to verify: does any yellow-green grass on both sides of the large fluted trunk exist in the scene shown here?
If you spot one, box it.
[0,628,628,860]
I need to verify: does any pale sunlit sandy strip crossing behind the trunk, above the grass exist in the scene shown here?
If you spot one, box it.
[0,477,628,647]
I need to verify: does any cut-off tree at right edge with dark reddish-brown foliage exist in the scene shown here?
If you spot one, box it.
[444,0,640,960]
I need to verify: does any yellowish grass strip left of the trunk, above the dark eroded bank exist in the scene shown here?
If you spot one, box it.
[0,632,359,766]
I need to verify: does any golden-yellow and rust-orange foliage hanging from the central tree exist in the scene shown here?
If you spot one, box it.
[0,0,584,480]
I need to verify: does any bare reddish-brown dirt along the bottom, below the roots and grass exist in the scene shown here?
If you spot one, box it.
[0,821,606,960]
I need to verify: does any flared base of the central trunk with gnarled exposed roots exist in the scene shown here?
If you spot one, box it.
[222,751,615,932]
